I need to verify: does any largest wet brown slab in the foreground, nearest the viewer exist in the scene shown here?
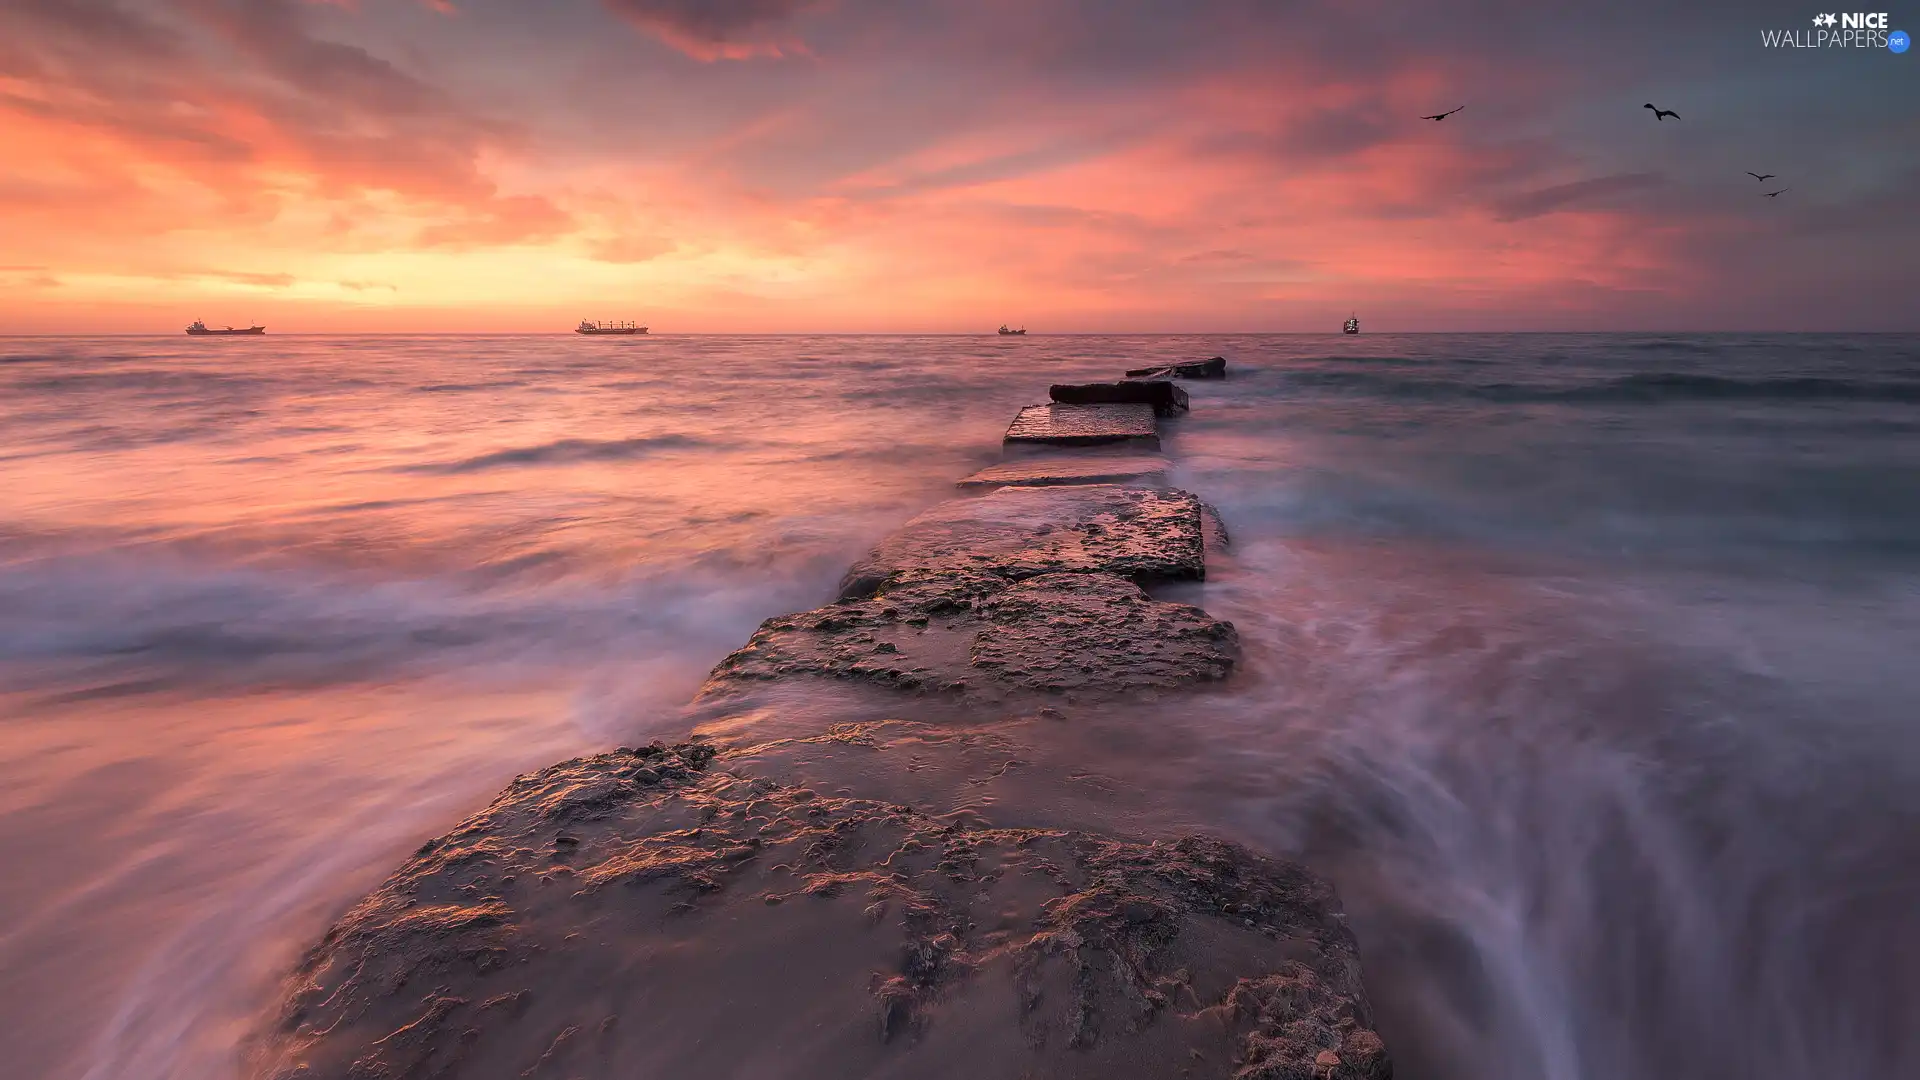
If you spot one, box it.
[250,744,1392,1080]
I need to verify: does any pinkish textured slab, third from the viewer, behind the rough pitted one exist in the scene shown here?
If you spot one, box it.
[839,484,1206,600]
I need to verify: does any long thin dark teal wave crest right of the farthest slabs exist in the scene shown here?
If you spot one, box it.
[1286,371,1920,404]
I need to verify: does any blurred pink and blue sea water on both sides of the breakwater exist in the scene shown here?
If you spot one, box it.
[0,334,1920,1080]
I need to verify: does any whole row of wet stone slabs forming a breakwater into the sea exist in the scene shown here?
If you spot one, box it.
[250,357,1392,1080]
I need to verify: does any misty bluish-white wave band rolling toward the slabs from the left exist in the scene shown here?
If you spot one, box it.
[0,548,847,687]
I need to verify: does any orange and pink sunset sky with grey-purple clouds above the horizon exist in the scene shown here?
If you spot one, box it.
[0,0,1920,332]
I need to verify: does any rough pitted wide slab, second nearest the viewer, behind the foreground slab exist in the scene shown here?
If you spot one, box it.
[701,571,1240,700]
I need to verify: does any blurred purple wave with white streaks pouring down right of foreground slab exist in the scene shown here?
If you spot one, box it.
[1187,530,1920,1080]
